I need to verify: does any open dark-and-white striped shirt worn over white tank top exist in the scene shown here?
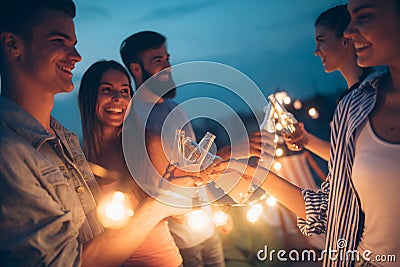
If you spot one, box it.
[298,73,383,266]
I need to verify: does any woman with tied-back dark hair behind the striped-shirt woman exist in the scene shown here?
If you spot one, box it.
[284,5,373,161]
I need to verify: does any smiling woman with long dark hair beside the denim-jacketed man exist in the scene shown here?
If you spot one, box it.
[78,60,182,267]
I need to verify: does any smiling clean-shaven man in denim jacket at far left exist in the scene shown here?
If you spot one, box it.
[0,0,194,266]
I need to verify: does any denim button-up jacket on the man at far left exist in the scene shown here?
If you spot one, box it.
[0,96,103,266]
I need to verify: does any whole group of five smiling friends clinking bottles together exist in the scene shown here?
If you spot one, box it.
[0,0,400,266]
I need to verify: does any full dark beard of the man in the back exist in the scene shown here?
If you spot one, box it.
[140,64,176,99]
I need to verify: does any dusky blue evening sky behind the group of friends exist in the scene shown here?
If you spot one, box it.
[53,0,346,142]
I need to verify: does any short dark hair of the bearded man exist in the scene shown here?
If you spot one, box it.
[120,31,167,70]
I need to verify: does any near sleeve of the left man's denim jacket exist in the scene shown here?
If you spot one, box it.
[0,142,82,266]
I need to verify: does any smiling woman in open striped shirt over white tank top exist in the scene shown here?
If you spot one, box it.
[216,0,400,266]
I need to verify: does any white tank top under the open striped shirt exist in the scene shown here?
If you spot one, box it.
[352,119,400,266]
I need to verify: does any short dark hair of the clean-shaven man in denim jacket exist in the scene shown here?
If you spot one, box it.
[0,0,76,38]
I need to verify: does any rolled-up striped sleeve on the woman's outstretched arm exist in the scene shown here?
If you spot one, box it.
[297,179,330,236]
